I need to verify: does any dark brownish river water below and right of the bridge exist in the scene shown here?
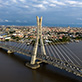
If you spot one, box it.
[0,42,82,82]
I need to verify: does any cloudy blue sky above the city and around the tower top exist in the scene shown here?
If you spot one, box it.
[0,0,82,25]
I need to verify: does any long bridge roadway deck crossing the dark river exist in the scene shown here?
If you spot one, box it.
[0,42,82,77]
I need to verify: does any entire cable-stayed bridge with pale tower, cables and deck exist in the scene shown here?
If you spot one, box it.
[0,17,82,77]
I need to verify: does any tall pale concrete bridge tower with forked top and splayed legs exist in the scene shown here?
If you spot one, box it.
[27,16,46,69]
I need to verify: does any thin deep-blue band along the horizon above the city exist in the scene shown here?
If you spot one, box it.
[0,22,82,27]
